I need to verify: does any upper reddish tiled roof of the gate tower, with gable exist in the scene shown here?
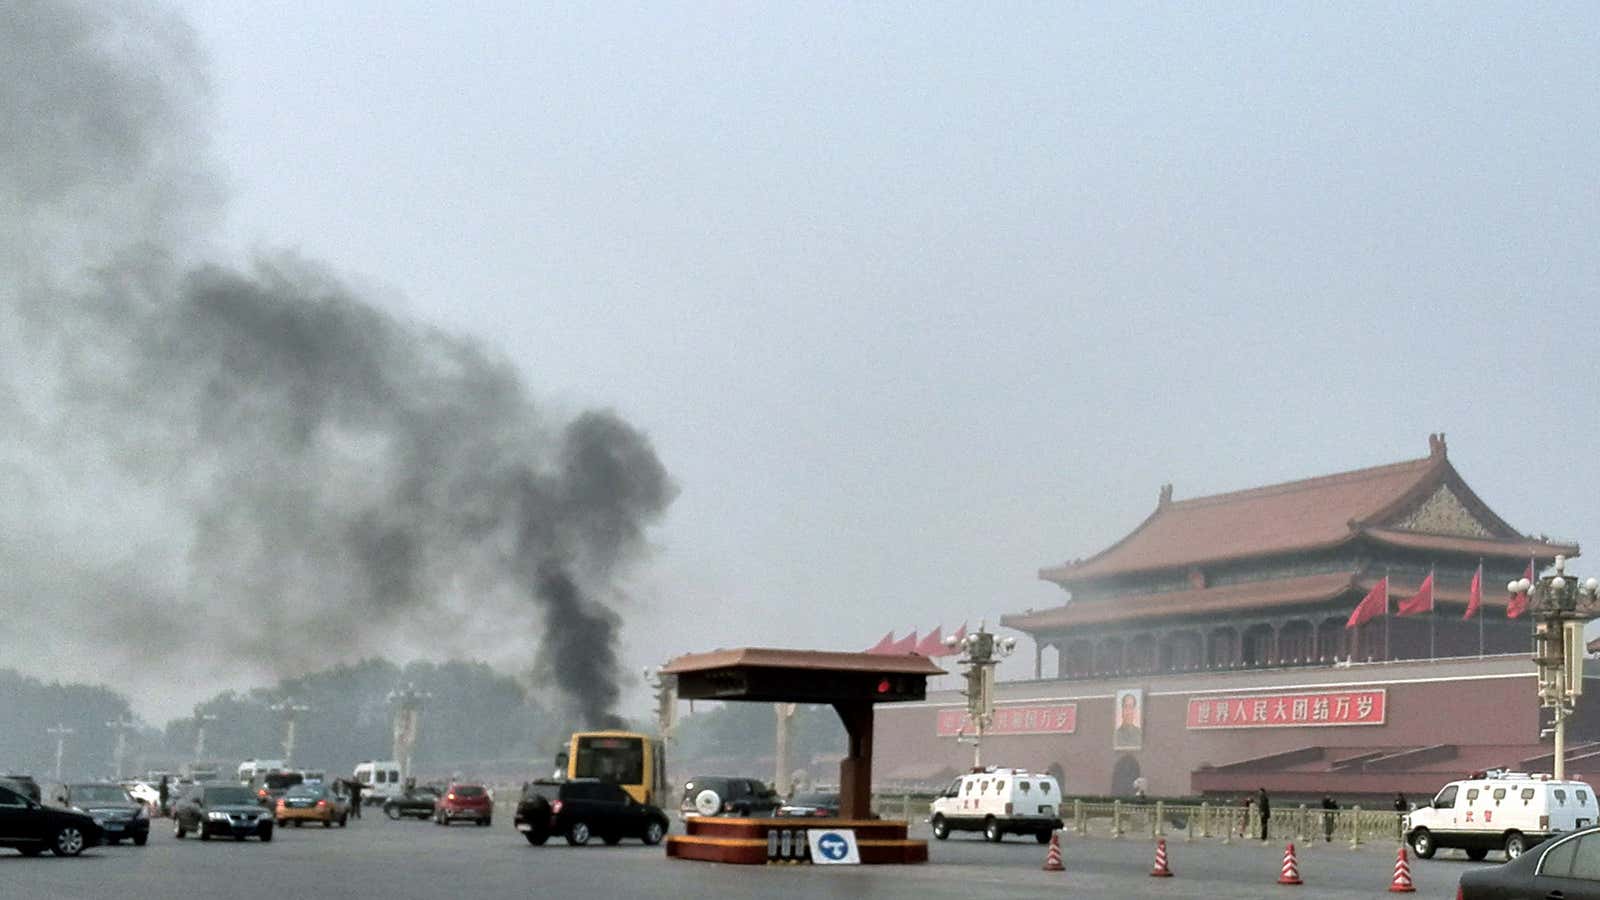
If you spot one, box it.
[1038,436,1548,588]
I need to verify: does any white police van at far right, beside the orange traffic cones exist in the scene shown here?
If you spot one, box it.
[1403,770,1600,860]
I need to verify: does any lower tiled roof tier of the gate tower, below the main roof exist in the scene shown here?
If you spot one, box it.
[1000,572,1362,631]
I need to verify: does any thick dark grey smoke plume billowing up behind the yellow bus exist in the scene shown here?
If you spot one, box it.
[0,2,674,724]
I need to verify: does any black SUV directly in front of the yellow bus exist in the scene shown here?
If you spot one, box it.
[515,778,667,847]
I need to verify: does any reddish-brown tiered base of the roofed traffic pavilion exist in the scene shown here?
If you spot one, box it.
[667,817,928,865]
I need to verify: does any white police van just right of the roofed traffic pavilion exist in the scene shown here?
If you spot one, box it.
[928,767,1061,844]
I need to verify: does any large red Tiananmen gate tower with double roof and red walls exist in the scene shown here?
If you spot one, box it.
[877,434,1600,798]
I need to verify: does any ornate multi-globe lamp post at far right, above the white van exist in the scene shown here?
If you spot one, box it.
[1506,556,1600,780]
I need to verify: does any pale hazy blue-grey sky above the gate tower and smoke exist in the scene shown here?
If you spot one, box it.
[43,0,1600,705]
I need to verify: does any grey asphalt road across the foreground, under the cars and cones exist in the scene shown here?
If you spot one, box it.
[0,817,1494,900]
